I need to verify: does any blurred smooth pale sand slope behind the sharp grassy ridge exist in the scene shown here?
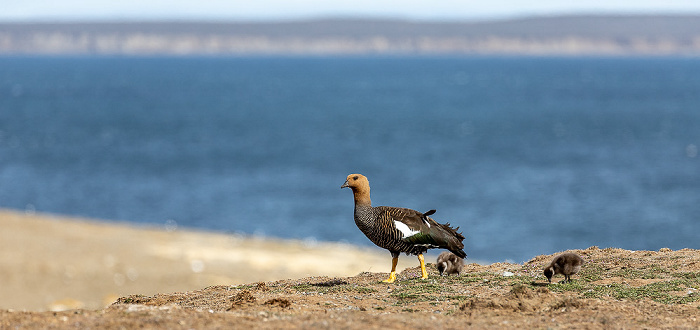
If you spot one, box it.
[0,210,418,311]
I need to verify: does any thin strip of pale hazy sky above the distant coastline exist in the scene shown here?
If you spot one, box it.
[0,0,700,21]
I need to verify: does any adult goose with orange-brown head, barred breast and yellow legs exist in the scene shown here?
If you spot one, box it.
[341,174,467,283]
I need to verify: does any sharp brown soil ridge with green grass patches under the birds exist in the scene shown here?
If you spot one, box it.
[0,247,700,329]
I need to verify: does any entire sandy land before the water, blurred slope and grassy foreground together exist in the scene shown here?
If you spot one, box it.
[0,212,700,329]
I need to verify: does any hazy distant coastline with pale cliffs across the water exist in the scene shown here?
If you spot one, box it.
[0,15,700,56]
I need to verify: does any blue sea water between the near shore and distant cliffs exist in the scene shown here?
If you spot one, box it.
[0,57,700,262]
